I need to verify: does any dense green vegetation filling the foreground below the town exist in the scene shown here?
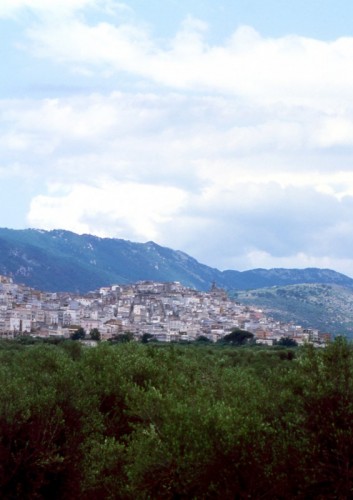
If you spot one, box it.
[0,338,353,500]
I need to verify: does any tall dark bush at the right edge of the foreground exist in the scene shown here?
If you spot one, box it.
[295,337,353,498]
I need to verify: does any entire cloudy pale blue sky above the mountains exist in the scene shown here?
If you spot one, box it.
[0,0,353,277]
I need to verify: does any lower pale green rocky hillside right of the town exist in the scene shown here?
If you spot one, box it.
[232,284,353,337]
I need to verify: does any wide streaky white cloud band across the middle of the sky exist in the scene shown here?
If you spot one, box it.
[0,92,353,188]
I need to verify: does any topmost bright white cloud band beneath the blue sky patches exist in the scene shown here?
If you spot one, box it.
[17,10,353,109]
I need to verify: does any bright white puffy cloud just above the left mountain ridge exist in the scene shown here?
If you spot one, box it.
[28,182,185,241]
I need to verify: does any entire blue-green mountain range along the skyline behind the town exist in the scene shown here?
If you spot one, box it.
[0,228,353,293]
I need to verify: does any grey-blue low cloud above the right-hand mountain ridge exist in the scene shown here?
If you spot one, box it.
[164,184,353,275]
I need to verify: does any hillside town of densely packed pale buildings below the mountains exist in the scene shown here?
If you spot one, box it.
[0,276,330,345]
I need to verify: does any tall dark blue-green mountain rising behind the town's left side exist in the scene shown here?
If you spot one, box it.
[0,229,219,293]
